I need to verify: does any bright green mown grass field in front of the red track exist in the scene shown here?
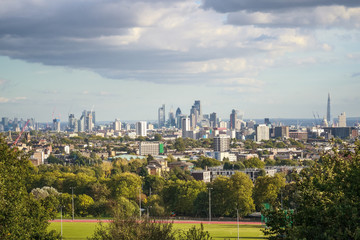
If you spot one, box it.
[49,222,265,240]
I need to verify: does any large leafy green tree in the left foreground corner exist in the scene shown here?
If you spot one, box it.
[0,137,59,239]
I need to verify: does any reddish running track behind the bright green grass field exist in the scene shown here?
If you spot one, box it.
[49,219,262,225]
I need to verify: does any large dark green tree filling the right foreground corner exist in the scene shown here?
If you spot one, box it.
[265,142,360,239]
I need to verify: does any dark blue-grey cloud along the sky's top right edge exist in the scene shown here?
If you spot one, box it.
[203,0,360,13]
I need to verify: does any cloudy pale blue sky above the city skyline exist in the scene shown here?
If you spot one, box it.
[0,0,360,122]
